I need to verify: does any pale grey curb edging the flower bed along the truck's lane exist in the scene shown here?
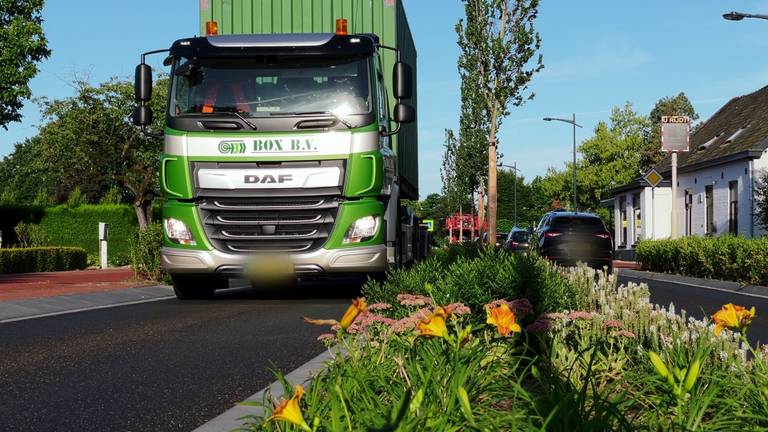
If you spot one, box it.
[193,347,343,432]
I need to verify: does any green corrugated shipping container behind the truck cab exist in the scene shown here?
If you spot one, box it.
[195,0,419,199]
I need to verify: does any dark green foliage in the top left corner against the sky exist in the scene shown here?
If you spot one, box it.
[0,0,51,130]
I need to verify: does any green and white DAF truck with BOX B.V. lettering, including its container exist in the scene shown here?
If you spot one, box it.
[133,0,425,299]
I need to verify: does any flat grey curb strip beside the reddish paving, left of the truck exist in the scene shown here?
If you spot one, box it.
[0,285,175,324]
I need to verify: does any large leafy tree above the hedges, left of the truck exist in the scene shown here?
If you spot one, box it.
[0,79,168,229]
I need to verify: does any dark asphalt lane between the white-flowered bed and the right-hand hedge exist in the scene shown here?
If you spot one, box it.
[619,273,768,344]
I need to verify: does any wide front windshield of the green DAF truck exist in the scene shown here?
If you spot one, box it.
[170,58,372,117]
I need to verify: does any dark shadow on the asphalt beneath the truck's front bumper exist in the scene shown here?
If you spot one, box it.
[210,277,365,300]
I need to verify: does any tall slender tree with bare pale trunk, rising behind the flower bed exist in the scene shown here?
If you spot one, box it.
[456,0,543,238]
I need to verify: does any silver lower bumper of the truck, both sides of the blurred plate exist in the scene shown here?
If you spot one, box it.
[160,245,387,276]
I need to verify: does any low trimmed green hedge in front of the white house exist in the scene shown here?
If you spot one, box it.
[636,236,768,285]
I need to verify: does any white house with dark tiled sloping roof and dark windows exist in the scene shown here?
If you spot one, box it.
[612,86,768,257]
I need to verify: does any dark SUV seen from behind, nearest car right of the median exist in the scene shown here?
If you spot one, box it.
[536,211,613,271]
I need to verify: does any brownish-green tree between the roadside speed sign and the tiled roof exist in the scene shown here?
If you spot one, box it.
[640,92,699,172]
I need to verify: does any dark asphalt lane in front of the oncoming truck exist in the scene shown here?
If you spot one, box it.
[0,284,359,431]
